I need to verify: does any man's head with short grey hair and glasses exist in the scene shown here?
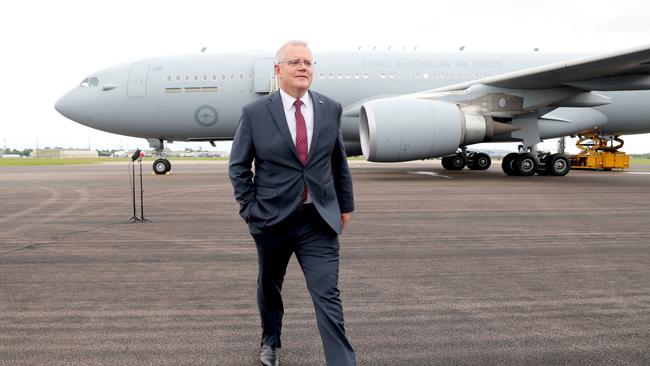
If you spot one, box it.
[275,45,314,98]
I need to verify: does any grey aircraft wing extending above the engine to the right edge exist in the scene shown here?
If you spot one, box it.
[424,45,650,93]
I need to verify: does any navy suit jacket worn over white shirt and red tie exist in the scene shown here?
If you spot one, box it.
[228,91,354,234]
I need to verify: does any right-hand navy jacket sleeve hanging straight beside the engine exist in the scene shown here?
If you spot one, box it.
[332,104,354,213]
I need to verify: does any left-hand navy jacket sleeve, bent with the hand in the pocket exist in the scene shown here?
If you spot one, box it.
[228,108,255,222]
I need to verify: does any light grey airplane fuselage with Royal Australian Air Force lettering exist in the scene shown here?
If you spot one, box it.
[56,52,650,152]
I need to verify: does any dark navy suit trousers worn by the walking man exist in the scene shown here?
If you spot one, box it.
[250,204,356,365]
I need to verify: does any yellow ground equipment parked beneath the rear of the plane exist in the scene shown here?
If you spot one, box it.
[571,135,630,170]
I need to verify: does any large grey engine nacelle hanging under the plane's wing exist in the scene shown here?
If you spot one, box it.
[359,98,496,162]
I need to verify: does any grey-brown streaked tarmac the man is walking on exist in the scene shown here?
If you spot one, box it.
[0,160,650,366]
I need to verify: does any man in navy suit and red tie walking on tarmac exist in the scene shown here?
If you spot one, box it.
[228,41,356,366]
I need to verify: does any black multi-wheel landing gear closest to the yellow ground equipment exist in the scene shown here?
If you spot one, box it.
[501,146,571,176]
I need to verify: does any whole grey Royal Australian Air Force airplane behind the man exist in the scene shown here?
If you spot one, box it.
[55,45,650,176]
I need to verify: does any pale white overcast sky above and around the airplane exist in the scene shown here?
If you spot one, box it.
[0,0,650,153]
